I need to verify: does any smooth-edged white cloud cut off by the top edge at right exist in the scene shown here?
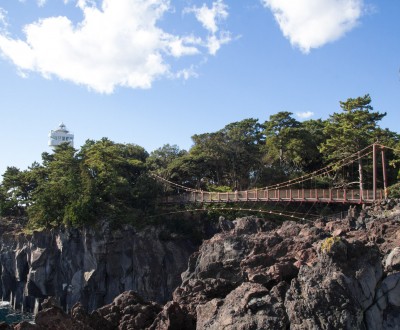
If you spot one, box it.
[262,0,364,53]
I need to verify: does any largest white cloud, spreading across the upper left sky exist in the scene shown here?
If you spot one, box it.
[0,0,229,93]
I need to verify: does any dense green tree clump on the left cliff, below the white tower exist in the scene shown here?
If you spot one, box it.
[0,138,158,227]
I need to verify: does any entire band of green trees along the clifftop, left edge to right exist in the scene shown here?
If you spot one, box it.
[0,95,400,228]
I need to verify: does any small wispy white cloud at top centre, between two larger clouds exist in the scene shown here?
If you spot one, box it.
[184,0,232,55]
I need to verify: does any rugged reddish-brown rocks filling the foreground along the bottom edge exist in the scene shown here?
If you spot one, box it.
[2,201,400,330]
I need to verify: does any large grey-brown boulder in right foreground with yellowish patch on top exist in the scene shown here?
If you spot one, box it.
[285,243,382,329]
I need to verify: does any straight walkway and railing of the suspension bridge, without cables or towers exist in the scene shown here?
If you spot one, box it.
[164,189,383,204]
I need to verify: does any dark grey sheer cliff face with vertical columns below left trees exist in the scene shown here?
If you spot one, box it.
[0,228,194,310]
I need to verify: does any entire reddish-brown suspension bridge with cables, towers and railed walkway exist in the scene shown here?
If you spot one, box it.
[153,143,391,204]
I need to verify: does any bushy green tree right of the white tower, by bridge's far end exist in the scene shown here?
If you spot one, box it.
[79,138,148,222]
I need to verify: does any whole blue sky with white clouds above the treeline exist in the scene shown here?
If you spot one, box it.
[0,0,400,178]
